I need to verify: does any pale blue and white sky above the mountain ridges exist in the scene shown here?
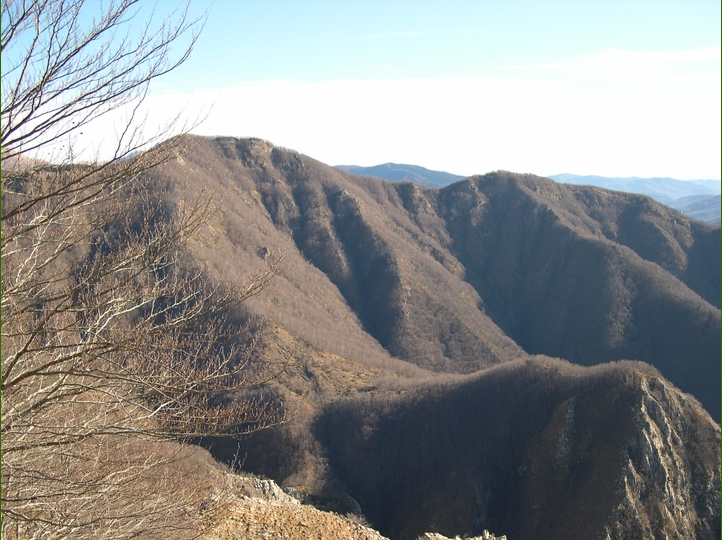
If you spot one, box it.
[43,0,722,179]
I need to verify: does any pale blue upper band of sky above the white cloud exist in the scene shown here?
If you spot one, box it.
[160,0,720,87]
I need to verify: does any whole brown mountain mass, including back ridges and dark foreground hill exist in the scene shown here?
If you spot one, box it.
[138,137,720,539]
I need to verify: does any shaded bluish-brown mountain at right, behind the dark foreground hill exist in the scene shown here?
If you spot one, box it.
[430,172,720,417]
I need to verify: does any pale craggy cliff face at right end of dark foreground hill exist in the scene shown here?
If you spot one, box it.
[606,378,720,540]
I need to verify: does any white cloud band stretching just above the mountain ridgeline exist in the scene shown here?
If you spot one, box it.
[64,48,720,179]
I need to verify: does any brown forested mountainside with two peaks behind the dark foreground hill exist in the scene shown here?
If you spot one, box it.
[148,138,720,417]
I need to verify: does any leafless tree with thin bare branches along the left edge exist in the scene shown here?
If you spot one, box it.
[1,0,283,538]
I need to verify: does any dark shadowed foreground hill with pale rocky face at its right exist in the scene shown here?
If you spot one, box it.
[316,358,719,540]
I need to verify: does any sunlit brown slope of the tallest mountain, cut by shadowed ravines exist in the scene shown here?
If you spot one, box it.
[152,138,523,372]
